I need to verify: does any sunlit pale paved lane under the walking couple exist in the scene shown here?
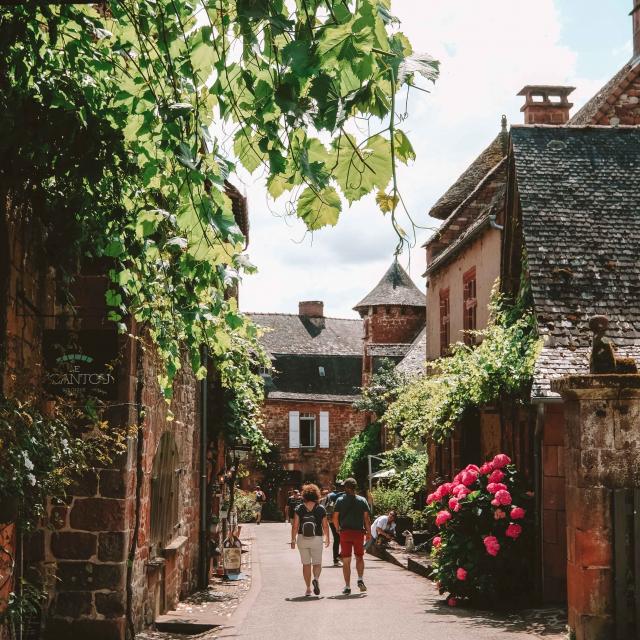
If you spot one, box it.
[220,523,563,640]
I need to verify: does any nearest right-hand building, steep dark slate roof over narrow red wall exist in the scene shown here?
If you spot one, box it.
[502,126,640,598]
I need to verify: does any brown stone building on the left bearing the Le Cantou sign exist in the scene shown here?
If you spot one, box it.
[0,186,246,640]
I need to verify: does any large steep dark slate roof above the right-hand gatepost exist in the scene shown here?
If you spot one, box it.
[511,126,640,394]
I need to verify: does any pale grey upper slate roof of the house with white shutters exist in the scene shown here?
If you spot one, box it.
[248,313,363,356]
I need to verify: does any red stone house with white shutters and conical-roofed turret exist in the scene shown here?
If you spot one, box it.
[247,261,425,509]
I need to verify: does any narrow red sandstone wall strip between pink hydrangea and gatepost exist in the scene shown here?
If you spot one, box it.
[542,404,567,602]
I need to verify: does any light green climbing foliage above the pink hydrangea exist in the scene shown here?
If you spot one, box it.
[384,297,540,446]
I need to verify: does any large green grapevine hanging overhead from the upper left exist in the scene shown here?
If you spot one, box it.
[0,0,438,428]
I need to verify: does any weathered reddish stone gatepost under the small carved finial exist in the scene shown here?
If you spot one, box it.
[552,374,640,640]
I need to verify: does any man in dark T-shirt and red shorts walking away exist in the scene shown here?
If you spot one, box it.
[333,478,371,596]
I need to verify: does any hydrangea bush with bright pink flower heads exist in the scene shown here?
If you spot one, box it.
[426,454,533,606]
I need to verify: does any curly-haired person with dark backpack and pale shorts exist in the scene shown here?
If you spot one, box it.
[291,484,329,596]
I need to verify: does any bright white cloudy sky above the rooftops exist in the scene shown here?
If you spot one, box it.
[240,0,632,317]
